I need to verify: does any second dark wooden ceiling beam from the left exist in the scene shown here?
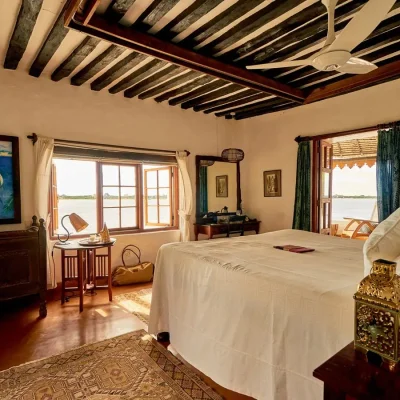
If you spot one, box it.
[29,2,68,78]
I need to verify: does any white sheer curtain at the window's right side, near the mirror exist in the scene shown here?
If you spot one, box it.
[176,151,193,242]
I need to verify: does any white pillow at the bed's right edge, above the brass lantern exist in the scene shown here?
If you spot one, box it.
[363,208,400,276]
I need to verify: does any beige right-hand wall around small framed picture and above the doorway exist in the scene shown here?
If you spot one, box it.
[234,80,400,232]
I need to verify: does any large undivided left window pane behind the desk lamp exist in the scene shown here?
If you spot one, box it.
[53,158,98,235]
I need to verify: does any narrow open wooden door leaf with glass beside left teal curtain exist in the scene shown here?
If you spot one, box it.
[318,140,333,235]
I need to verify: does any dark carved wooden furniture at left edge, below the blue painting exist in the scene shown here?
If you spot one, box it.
[0,217,47,317]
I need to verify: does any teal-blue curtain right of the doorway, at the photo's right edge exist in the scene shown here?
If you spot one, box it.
[376,123,400,221]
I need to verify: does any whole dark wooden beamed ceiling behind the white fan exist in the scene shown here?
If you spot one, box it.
[4,0,400,119]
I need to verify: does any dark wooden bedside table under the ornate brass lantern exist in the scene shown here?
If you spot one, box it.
[313,342,400,400]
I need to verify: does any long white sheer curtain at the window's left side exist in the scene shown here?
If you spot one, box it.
[33,136,57,289]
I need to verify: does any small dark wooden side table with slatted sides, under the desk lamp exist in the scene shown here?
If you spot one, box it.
[54,239,116,312]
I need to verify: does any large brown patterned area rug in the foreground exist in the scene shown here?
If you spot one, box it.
[0,330,222,400]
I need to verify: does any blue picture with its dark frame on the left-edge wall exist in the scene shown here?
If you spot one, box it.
[0,135,21,225]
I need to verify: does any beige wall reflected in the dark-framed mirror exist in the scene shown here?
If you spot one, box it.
[207,161,237,212]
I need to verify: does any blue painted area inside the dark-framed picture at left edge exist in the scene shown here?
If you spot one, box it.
[0,156,14,219]
